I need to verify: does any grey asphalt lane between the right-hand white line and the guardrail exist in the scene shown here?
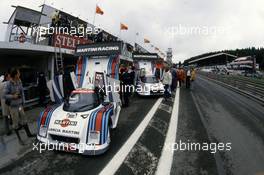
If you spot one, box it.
[171,78,264,175]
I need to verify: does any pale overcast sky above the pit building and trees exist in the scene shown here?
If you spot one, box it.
[0,0,264,62]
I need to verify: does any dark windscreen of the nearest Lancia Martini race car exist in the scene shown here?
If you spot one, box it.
[63,92,100,112]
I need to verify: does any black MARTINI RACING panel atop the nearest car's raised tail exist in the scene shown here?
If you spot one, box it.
[75,42,122,56]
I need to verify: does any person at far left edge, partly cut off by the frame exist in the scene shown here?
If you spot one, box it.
[0,71,12,135]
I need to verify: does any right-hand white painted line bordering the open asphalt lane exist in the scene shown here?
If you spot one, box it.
[156,87,180,175]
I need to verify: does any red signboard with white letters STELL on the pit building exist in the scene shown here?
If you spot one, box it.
[53,34,91,50]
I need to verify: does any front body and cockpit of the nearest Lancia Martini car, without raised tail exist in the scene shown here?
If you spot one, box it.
[37,89,121,155]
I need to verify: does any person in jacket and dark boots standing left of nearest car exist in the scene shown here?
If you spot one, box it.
[4,69,35,145]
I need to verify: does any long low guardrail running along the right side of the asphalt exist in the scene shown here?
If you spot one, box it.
[198,72,264,102]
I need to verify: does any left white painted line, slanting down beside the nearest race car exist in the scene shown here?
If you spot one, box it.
[100,98,162,175]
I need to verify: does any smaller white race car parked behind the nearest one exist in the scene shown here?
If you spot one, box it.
[136,75,165,96]
